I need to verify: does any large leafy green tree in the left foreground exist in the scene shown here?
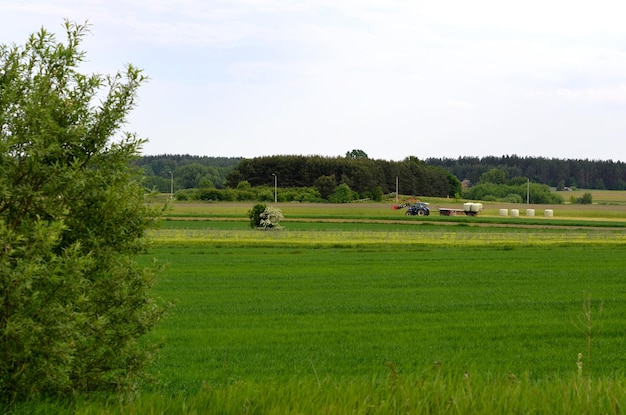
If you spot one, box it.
[0,22,163,402]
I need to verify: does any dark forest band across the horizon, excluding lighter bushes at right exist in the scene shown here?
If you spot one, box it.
[136,154,626,196]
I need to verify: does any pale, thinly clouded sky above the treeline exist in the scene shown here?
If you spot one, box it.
[0,0,626,161]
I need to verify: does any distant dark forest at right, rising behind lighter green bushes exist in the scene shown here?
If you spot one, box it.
[426,155,626,190]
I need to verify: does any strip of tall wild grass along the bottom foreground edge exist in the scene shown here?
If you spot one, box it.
[10,367,626,415]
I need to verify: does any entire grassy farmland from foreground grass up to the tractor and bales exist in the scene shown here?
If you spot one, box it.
[7,197,626,414]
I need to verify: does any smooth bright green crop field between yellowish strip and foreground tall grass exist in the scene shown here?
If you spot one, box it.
[144,245,626,386]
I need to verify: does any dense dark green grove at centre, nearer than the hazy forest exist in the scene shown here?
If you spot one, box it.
[226,157,461,199]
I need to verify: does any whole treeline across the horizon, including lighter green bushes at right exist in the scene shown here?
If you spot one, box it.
[135,154,626,203]
